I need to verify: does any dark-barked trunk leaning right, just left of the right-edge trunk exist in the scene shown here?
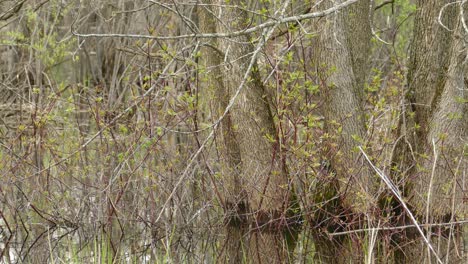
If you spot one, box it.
[393,0,456,187]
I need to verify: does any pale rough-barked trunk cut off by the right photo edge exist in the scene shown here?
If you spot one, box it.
[415,25,468,217]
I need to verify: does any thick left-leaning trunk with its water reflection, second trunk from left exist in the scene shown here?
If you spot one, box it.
[218,1,296,263]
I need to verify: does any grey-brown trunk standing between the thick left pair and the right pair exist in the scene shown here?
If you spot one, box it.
[317,1,372,217]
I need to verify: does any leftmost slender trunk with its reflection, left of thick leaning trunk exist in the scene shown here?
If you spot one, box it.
[197,1,245,263]
